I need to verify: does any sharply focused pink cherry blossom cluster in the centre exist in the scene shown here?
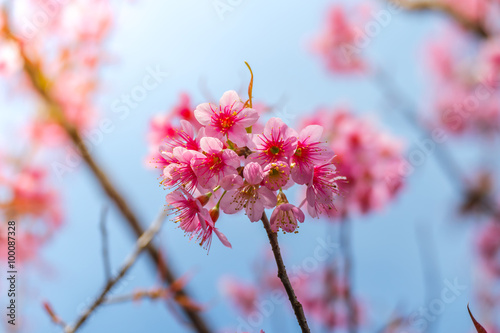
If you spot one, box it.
[155,91,342,247]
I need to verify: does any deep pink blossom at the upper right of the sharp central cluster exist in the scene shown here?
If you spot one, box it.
[291,125,333,184]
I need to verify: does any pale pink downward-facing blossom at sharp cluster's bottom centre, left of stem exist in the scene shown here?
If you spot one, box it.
[221,162,277,222]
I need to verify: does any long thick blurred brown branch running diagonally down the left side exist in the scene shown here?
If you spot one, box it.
[3,10,211,333]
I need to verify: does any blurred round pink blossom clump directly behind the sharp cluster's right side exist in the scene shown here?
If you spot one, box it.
[303,109,404,217]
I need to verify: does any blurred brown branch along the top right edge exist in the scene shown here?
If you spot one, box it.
[388,0,490,38]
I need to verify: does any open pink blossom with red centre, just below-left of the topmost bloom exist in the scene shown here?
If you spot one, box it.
[191,137,240,189]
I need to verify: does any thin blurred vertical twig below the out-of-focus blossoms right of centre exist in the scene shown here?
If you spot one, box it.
[340,218,358,333]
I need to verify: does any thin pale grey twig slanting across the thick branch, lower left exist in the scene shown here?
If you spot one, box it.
[65,210,167,333]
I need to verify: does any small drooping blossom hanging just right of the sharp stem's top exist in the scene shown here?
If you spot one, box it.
[269,192,305,232]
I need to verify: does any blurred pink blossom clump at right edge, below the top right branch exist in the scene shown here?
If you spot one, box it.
[427,30,500,134]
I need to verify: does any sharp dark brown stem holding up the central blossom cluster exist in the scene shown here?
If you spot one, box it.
[261,212,310,332]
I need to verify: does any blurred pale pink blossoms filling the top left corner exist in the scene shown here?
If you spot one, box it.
[0,0,113,143]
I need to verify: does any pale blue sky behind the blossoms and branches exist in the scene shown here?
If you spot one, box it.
[0,0,488,333]
